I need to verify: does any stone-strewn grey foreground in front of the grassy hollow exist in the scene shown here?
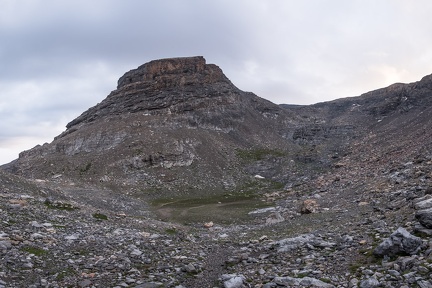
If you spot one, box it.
[0,150,432,288]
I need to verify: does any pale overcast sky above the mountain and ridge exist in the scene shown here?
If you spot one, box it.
[0,0,432,164]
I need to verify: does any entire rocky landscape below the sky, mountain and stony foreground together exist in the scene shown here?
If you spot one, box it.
[0,57,432,288]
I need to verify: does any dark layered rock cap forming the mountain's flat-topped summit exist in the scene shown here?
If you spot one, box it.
[66,56,240,128]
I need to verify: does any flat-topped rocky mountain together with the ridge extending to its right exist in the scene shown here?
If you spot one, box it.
[3,57,432,197]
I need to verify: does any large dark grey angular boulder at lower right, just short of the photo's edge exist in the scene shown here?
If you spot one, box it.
[373,227,422,256]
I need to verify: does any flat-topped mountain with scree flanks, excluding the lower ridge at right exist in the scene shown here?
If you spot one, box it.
[2,57,308,195]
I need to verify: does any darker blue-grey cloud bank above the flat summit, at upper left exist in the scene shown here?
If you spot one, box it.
[0,1,250,77]
